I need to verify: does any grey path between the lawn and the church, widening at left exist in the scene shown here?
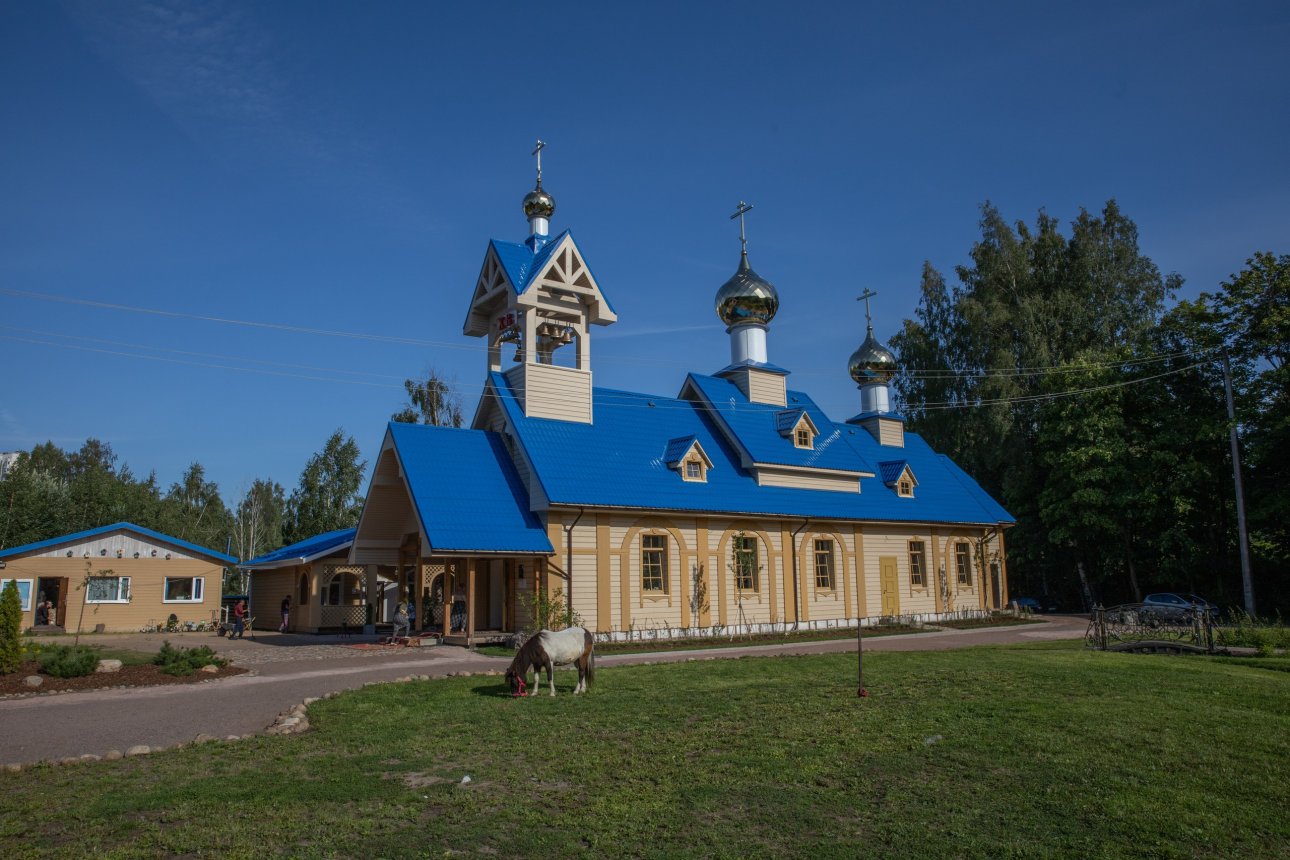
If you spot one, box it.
[0,616,1087,765]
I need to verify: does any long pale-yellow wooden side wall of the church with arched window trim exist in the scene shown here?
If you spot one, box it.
[548,511,1006,632]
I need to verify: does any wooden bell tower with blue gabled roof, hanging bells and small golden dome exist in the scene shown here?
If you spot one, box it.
[462,141,618,424]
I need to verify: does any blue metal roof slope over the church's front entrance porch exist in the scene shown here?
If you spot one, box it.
[387,423,553,554]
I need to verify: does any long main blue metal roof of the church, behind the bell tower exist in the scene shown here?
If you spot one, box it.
[487,373,1013,523]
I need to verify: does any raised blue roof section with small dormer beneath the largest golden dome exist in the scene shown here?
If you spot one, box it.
[686,374,873,472]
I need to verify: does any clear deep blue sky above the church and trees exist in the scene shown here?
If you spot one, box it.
[0,0,1290,499]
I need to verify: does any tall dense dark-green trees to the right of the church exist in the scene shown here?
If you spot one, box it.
[891,201,1290,606]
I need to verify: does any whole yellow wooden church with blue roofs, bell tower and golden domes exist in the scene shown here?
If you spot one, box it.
[337,147,1014,642]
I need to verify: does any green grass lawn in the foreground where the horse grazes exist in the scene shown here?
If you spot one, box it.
[0,643,1290,859]
